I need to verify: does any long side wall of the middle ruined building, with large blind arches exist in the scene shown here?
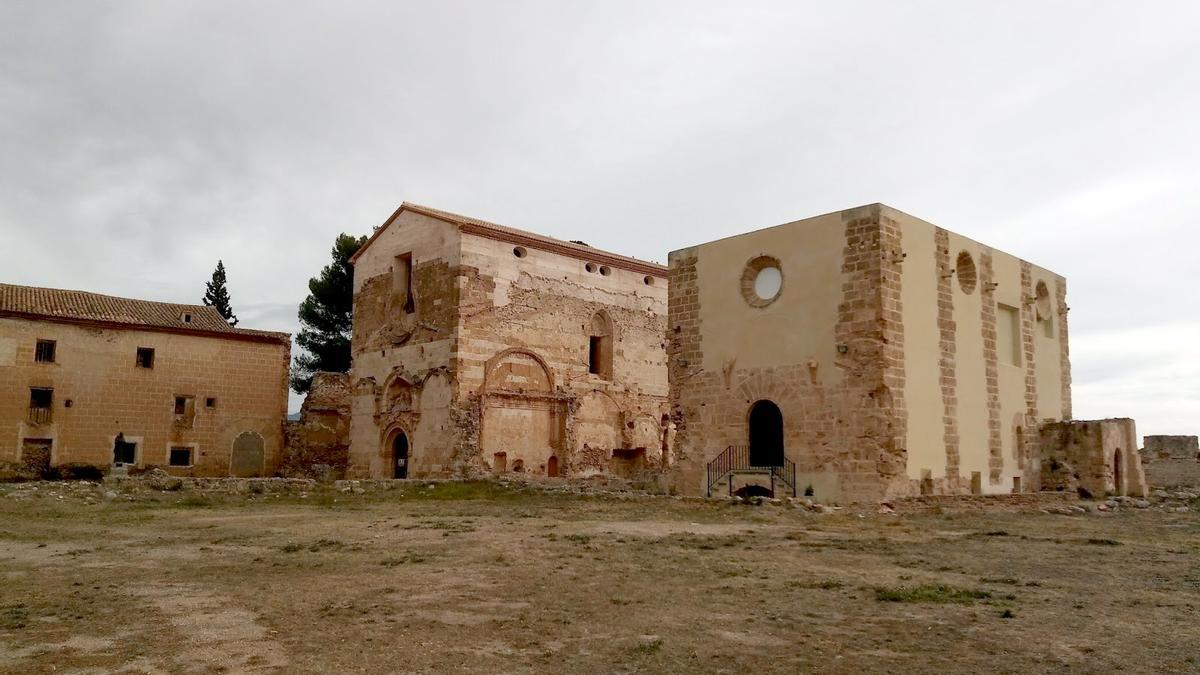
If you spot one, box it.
[456,230,670,476]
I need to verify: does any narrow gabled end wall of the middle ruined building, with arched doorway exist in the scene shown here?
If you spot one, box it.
[347,213,462,478]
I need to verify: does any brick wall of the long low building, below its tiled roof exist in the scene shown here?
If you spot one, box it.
[0,318,290,476]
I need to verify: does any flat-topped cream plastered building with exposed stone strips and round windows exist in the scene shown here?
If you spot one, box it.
[668,204,1070,501]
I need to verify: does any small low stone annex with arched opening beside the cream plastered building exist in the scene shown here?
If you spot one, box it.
[1038,418,1148,497]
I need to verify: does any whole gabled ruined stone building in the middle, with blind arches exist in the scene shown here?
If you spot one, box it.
[348,203,670,478]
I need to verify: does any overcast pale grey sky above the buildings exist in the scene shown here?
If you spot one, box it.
[0,0,1200,434]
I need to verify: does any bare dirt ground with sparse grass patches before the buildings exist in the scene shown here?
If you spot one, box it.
[0,484,1200,673]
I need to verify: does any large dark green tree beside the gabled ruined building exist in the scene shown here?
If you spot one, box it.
[292,234,367,394]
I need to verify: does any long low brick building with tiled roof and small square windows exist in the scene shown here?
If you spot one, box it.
[0,285,290,477]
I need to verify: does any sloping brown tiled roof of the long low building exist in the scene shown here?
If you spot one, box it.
[0,283,290,340]
